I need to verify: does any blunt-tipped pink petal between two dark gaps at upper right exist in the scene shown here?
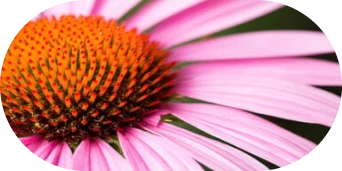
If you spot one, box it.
[168,31,335,62]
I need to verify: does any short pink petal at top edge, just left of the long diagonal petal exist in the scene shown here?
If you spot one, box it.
[125,0,203,31]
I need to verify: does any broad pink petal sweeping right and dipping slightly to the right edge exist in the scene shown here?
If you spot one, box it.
[176,75,341,126]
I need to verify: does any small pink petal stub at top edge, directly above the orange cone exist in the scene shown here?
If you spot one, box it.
[70,0,97,16]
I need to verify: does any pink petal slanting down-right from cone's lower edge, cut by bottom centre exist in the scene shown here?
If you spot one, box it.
[118,129,203,171]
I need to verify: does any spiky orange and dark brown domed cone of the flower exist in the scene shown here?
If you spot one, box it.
[0,15,176,142]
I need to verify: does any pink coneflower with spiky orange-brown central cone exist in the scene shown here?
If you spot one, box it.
[0,0,342,171]
